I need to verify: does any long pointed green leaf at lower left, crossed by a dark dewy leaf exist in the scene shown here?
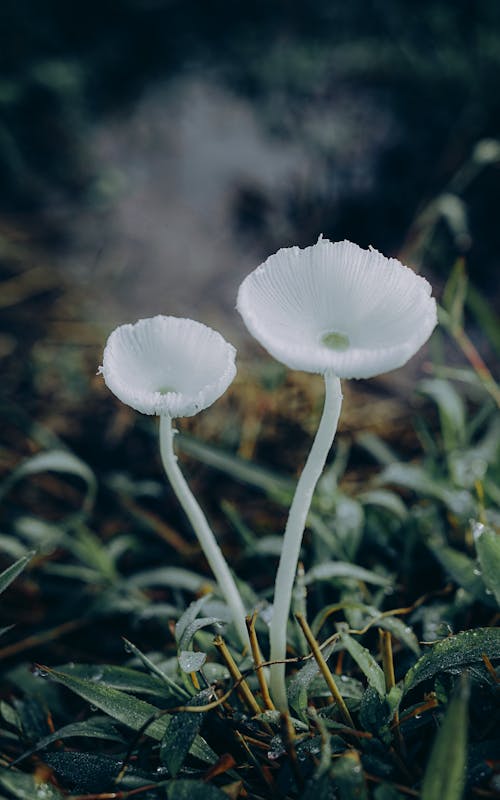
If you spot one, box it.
[43,667,217,764]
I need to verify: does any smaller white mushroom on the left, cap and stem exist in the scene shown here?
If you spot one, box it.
[99,315,249,647]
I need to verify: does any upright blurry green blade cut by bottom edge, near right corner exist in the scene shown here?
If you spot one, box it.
[421,677,469,800]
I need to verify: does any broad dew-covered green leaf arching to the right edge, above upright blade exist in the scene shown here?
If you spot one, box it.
[403,628,500,694]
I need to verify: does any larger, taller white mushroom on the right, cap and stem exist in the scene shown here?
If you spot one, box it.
[237,236,437,711]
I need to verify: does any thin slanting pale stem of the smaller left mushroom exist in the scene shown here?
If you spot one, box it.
[160,414,250,648]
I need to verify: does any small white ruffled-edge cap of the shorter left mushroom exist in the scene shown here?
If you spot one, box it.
[99,315,236,418]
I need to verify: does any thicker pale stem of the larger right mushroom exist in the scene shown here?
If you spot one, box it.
[270,372,342,711]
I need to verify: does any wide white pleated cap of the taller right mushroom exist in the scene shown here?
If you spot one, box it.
[237,237,437,378]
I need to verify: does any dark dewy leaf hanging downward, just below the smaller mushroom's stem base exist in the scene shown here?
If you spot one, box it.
[160,689,213,778]
